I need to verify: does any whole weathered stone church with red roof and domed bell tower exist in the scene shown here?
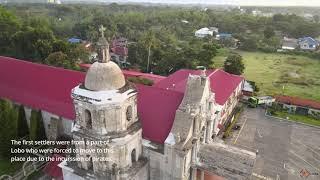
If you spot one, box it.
[0,27,255,180]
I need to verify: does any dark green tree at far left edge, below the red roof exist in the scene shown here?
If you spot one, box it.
[0,100,18,158]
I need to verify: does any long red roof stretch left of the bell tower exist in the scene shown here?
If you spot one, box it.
[0,56,85,119]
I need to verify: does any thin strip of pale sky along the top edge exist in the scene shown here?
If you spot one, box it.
[105,0,320,6]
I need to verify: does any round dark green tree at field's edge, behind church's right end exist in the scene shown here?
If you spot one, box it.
[224,53,245,75]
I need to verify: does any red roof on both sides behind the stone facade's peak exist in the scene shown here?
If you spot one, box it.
[154,69,244,105]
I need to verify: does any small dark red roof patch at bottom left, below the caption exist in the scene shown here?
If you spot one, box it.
[43,154,63,180]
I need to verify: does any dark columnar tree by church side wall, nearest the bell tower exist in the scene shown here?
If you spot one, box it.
[30,110,46,141]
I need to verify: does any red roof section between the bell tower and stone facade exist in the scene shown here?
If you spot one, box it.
[137,85,183,143]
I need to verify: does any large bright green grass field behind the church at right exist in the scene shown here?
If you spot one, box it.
[214,49,320,101]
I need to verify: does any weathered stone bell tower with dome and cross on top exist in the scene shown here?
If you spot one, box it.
[62,26,148,180]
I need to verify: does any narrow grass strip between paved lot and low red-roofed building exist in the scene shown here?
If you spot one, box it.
[273,111,320,126]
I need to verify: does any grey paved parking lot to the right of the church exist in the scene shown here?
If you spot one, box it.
[227,108,320,180]
